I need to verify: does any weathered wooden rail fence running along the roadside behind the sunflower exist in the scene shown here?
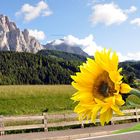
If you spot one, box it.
[0,108,140,135]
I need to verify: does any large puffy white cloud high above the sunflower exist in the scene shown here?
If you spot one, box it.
[91,3,128,26]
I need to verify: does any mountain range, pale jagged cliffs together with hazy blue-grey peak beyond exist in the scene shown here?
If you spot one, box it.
[0,15,88,56]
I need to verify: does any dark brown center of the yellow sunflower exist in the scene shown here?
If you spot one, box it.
[93,71,116,99]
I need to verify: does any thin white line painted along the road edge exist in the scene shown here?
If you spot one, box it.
[76,131,140,140]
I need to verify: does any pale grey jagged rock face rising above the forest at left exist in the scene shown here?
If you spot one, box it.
[0,15,43,53]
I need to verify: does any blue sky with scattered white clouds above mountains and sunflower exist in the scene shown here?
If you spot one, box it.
[0,0,140,60]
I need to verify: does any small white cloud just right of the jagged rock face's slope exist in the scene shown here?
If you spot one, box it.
[28,29,46,41]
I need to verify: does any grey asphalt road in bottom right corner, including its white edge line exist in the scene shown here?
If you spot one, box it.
[80,131,140,140]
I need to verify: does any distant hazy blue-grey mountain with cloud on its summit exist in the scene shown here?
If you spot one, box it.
[44,39,88,56]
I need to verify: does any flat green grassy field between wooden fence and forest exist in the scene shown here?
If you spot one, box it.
[0,85,75,115]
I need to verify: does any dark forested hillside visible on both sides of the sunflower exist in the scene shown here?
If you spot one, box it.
[0,50,140,85]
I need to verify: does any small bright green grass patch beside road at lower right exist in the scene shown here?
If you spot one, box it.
[114,123,140,134]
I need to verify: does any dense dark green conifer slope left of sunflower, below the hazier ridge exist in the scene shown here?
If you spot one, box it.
[0,52,85,85]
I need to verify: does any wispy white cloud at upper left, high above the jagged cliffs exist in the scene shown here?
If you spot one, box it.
[16,1,52,22]
